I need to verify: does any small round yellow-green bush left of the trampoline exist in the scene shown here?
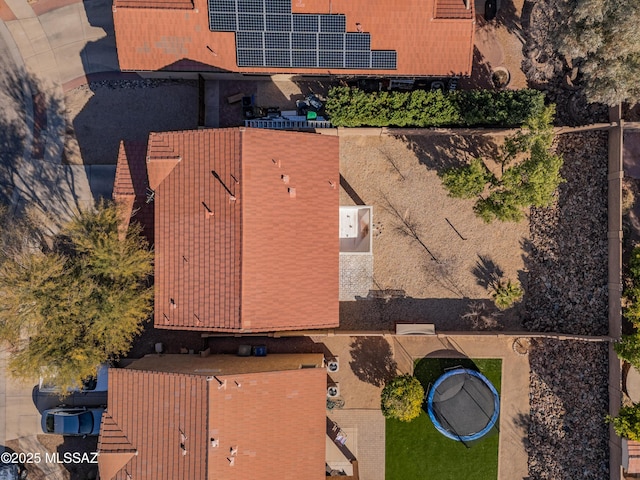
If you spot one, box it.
[381,375,424,422]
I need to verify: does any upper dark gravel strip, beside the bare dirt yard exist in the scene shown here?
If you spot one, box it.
[525,132,608,335]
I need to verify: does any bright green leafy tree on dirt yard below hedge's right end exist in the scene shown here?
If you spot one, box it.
[441,105,564,223]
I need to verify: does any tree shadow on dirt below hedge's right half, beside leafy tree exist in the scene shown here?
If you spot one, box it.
[394,130,499,173]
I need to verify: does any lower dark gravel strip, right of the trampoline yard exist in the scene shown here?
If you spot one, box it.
[528,340,609,480]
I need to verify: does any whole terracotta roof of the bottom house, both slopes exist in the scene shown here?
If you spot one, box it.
[98,360,326,480]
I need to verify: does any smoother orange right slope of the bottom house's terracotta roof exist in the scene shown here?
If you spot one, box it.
[208,368,327,480]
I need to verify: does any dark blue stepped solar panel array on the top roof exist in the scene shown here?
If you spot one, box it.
[209,0,397,70]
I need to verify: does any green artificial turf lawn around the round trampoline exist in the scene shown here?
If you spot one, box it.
[386,358,502,480]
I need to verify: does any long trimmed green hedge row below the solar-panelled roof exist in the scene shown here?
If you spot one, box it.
[325,87,544,127]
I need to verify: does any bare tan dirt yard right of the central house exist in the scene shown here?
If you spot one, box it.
[340,132,529,330]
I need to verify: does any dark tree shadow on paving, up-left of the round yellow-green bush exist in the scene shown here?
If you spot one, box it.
[349,337,398,387]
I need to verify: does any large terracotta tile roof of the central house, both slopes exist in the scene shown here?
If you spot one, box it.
[147,128,339,332]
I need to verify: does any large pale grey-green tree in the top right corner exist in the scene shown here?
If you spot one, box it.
[554,0,640,105]
